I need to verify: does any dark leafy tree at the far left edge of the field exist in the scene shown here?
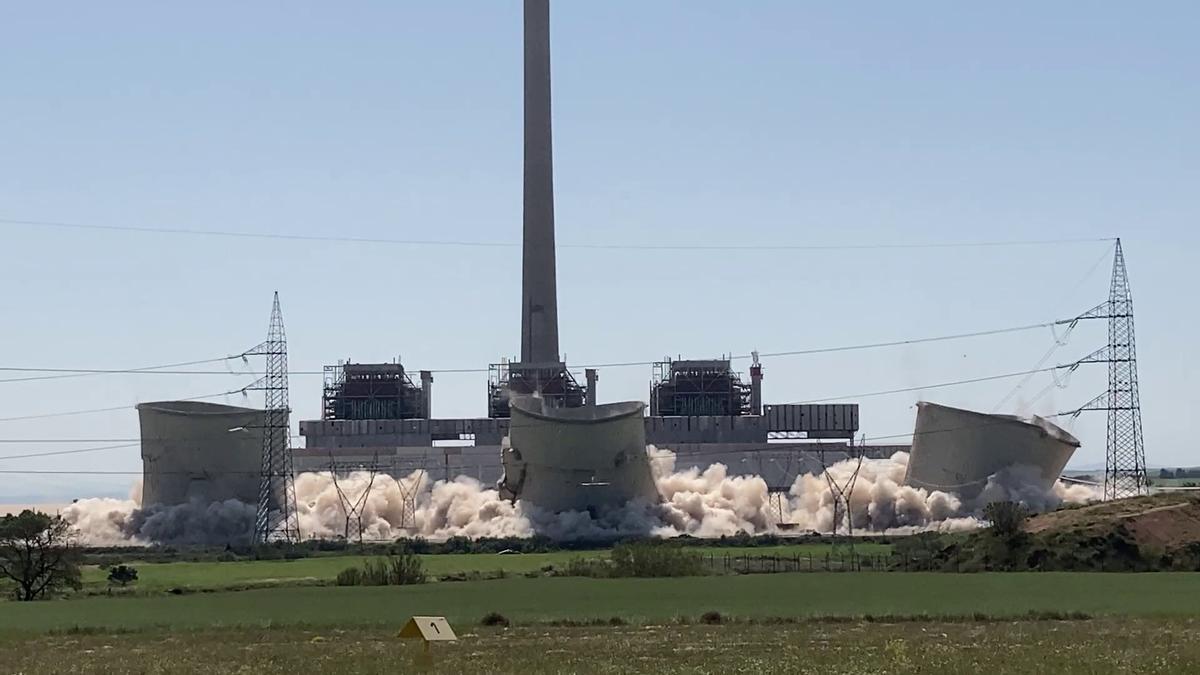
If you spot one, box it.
[0,509,80,601]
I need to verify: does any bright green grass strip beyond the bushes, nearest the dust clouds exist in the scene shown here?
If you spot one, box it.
[83,543,890,592]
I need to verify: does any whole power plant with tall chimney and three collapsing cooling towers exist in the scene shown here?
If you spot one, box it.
[129,0,1099,526]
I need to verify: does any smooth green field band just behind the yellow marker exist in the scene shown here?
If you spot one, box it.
[9,572,1200,634]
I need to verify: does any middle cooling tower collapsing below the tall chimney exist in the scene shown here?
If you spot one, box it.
[500,396,661,514]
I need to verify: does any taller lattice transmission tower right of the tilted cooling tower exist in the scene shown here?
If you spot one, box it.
[1076,239,1150,500]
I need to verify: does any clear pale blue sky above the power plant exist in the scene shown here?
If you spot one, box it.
[0,0,1200,498]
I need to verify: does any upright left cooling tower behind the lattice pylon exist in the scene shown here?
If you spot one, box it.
[138,401,264,506]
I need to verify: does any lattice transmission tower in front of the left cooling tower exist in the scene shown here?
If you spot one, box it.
[246,291,300,543]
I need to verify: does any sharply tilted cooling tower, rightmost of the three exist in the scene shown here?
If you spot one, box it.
[905,401,1080,500]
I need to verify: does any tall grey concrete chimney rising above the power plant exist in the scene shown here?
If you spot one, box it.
[521,0,559,364]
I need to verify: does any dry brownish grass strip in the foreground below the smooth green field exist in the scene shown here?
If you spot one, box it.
[0,619,1200,675]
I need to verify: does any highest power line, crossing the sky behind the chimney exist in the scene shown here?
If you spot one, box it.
[0,219,1115,251]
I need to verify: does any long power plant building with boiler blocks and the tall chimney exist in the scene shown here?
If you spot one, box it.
[294,0,873,494]
